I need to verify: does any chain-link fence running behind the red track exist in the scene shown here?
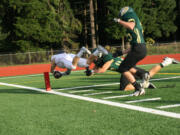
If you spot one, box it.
[0,42,180,67]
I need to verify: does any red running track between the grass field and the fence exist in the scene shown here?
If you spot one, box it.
[0,54,180,77]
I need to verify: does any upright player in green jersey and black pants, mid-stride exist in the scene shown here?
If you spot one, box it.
[114,7,148,96]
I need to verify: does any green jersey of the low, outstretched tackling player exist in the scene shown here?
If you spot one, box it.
[102,53,123,71]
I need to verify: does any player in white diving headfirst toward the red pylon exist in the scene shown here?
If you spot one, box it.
[50,47,91,79]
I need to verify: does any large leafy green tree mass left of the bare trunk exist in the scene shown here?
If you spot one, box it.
[0,0,81,52]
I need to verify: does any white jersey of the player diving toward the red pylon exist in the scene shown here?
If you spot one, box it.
[51,53,88,69]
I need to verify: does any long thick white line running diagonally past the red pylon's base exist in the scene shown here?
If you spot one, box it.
[0,82,180,119]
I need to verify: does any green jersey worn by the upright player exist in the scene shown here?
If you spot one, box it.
[121,10,145,45]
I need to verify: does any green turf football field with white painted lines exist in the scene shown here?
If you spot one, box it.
[0,64,180,135]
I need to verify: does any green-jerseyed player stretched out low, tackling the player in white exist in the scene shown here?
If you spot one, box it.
[87,46,179,92]
